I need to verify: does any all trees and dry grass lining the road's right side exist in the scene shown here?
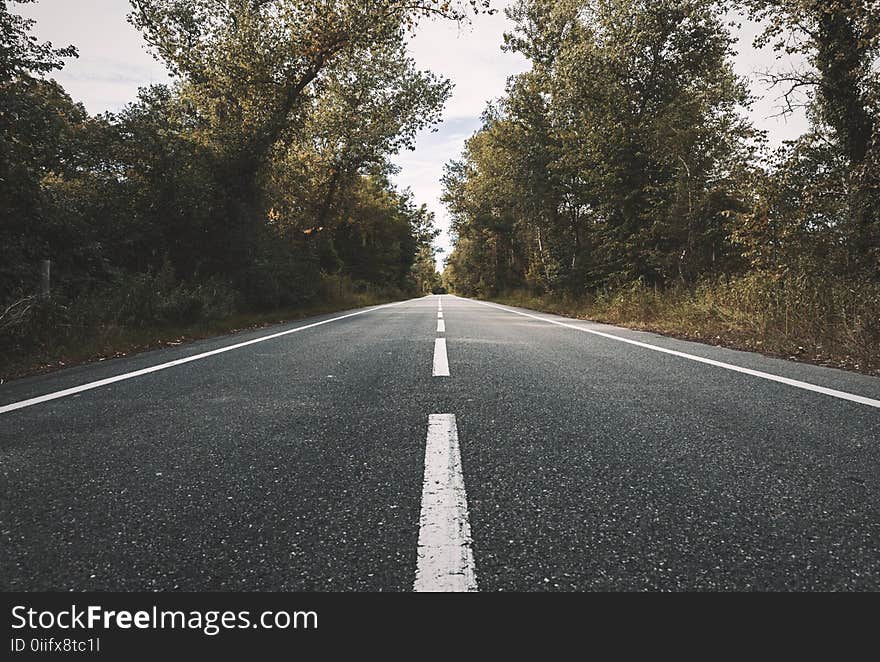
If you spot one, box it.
[444,0,880,373]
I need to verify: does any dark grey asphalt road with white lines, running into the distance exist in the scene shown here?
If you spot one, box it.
[0,296,880,591]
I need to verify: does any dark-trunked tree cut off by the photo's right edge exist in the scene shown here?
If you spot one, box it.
[746,0,880,278]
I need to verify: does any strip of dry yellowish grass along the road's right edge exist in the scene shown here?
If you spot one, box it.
[494,273,880,375]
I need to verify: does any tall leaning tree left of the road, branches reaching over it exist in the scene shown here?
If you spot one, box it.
[130,0,488,274]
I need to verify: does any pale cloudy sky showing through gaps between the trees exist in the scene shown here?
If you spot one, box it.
[15,0,806,270]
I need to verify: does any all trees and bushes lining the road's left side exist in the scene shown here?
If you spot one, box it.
[0,0,474,378]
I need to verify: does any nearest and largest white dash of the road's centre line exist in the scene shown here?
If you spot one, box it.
[413,414,477,592]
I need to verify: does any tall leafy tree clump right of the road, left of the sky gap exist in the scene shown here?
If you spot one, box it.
[445,0,754,294]
